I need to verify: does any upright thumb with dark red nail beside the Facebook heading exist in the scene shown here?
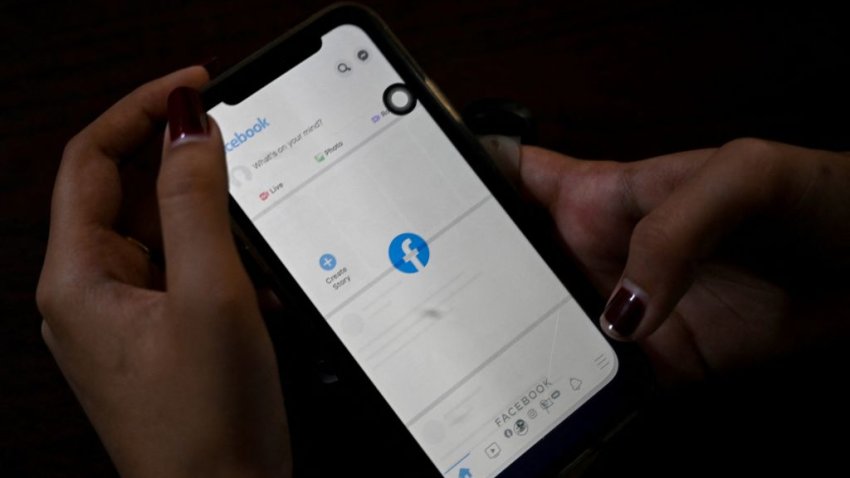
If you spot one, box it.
[157,87,245,294]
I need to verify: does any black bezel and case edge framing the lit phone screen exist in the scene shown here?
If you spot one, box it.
[202,4,652,477]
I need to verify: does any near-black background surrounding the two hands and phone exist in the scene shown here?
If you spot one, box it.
[0,0,850,476]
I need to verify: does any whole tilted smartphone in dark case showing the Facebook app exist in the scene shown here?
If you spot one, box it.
[204,4,648,478]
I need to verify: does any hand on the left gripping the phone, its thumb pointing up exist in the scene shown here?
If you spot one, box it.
[37,67,290,477]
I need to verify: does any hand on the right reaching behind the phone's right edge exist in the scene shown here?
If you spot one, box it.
[510,139,850,379]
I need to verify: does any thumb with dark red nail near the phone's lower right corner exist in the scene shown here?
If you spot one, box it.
[600,140,811,340]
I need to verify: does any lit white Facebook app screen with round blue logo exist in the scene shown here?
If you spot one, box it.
[210,25,617,477]
